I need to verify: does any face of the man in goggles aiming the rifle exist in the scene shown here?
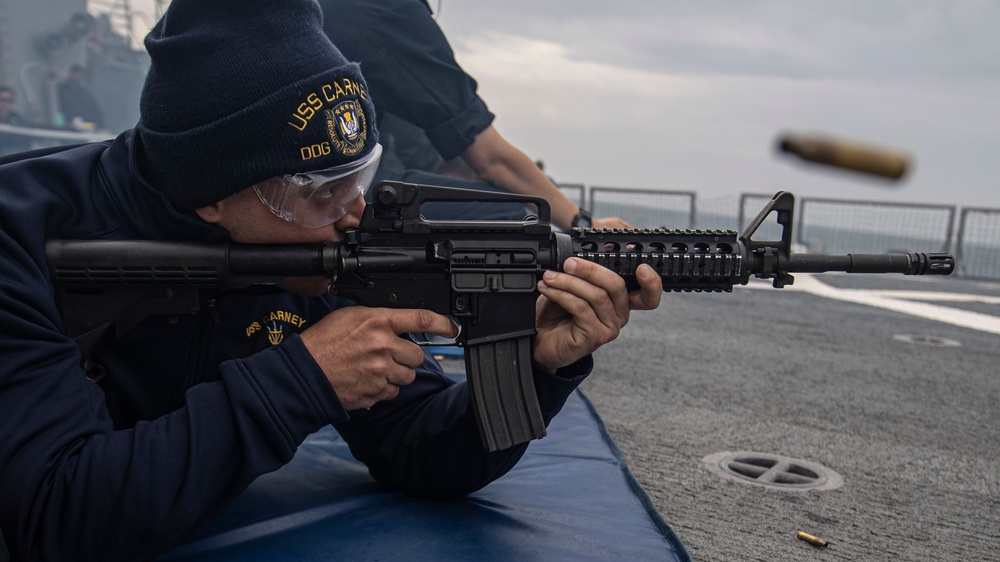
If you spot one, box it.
[196,187,365,296]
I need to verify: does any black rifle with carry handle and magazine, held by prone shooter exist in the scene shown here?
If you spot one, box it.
[46,182,955,451]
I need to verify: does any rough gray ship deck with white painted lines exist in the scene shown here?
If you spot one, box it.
[583,275,1000,561]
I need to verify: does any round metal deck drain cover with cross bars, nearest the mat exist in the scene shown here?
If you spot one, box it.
[702,451,844,491]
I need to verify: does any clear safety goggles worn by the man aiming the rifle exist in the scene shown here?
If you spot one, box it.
[254,144,382,228]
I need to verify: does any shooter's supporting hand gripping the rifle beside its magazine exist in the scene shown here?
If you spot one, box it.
[532,258,663,372]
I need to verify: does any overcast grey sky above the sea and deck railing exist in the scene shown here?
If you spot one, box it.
[430,0,1000,208]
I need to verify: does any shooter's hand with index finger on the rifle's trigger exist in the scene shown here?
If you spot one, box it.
[302,306,458,411]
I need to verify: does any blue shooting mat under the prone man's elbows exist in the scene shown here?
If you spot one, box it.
[158,378,690,562]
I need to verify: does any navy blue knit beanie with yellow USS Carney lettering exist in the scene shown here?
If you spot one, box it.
[136,0,378,211]
